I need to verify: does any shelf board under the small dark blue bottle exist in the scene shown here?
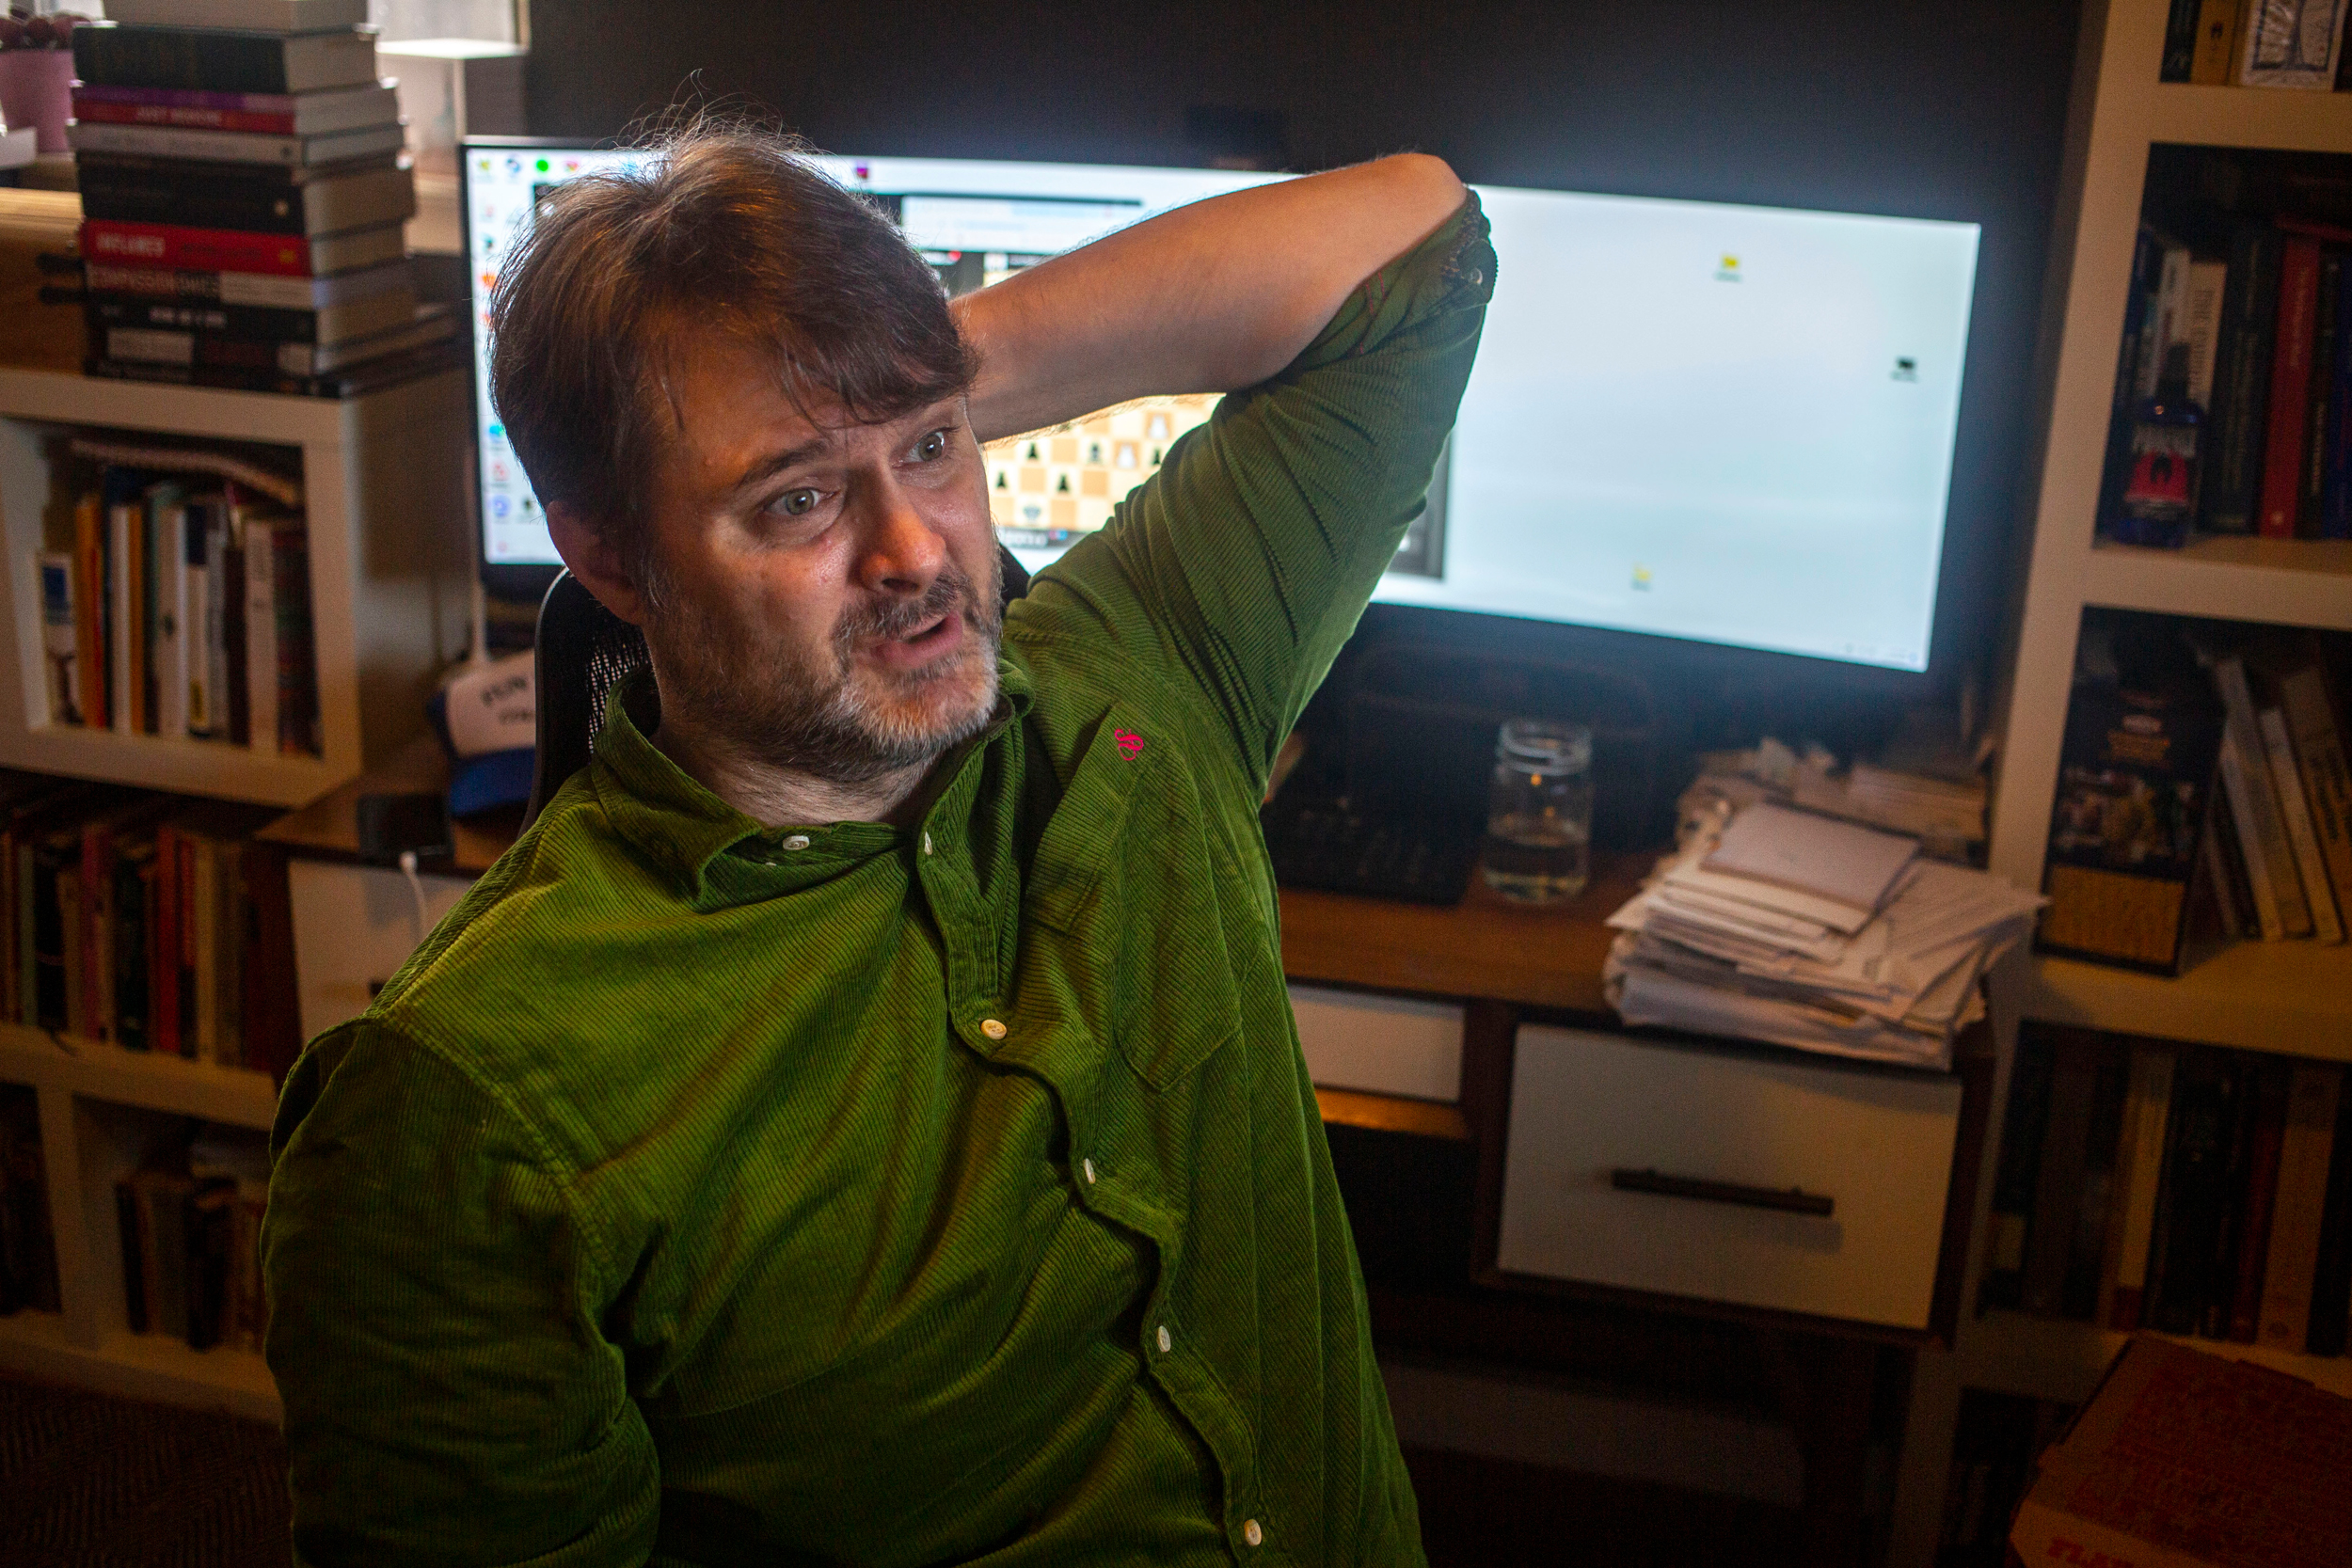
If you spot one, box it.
[2084,535,2352,630]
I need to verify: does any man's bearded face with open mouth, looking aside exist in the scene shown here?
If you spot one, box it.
[643,334,1002,783]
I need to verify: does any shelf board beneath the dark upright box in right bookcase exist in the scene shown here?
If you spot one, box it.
[2018,941,2352,1063]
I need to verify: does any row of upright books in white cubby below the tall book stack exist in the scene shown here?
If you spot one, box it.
[36,437,323,757]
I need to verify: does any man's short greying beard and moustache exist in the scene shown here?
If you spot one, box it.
[647,557,1005,785]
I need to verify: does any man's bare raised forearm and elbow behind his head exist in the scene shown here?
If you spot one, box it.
[955,152,1463,442]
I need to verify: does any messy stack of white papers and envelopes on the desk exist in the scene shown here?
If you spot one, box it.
[1607,804,2042,1068]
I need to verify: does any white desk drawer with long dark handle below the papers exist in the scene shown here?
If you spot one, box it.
[1496,1025,1960,1328]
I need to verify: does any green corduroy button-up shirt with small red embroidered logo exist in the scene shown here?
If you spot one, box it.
[263,199,1494,1566]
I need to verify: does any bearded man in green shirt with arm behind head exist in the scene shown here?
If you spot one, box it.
[263,132,1494,1563]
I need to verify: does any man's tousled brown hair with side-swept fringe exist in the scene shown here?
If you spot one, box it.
[489,119,977,571]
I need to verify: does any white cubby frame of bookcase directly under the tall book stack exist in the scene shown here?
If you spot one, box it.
[0,369,470,806]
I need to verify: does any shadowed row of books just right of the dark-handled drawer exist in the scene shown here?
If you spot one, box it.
[1979,1025,2352,1356]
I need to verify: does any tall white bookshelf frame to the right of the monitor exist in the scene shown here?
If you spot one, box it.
[1886,0,2352,1568]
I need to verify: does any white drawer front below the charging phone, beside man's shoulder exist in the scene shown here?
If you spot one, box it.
[287,858,473,1039]
